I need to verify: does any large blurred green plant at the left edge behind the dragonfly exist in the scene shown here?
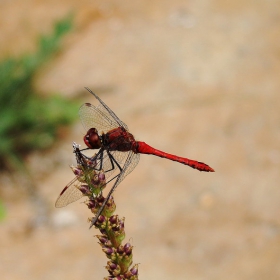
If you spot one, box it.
[0,16,78,170]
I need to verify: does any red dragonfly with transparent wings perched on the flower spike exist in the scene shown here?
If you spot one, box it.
[55,87,214,228]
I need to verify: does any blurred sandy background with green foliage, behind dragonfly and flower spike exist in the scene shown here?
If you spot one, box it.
[0,0,280,280]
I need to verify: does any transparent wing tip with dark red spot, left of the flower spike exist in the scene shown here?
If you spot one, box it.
[55,177,84,208]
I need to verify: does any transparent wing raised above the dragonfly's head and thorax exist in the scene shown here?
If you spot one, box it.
[79,89,128,133]
